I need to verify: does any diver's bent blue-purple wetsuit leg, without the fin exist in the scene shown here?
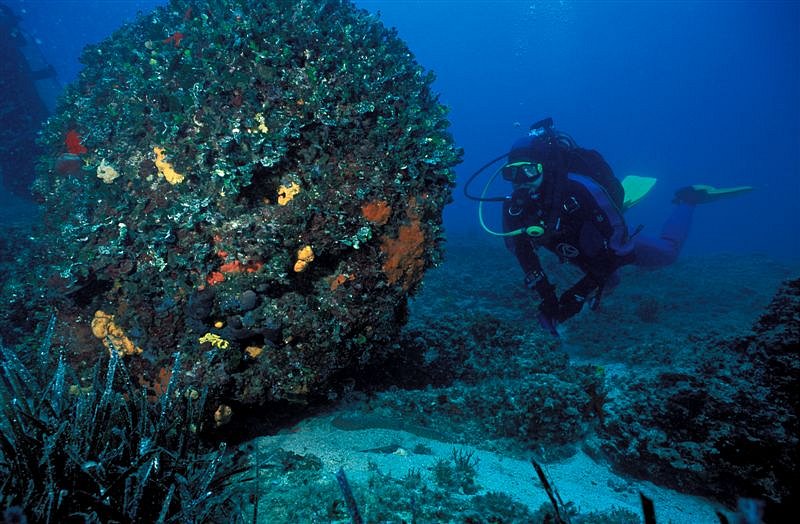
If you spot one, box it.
[633,204,694,267]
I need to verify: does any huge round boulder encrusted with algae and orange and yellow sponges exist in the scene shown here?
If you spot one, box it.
[28,0,460,421]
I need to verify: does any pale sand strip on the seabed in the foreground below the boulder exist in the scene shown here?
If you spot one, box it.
[256,415,723,524]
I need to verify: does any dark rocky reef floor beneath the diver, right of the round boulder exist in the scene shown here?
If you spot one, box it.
[354,240,800,522]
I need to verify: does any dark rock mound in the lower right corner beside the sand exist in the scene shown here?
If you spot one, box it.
[594,279,800,522]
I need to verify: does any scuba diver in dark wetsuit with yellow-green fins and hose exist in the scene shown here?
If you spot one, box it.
[464,118,752,336]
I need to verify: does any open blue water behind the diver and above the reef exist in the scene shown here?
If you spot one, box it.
[6,0,800,258]
